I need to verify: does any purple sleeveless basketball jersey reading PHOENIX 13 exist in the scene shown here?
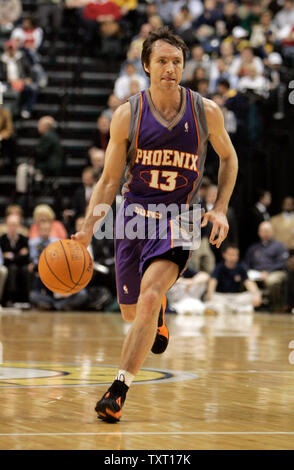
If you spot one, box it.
[122,88,208,209]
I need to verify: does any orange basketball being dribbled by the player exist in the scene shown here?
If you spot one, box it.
[38,239,93,294]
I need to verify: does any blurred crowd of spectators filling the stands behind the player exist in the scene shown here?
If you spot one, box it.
[0,0,294,313]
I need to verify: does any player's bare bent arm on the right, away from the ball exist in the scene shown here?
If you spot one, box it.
[201,98,238,248]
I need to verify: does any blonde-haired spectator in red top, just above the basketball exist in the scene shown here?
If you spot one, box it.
[29,204,67,240]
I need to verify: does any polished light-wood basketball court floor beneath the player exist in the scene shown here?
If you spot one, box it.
[0,312,294,450]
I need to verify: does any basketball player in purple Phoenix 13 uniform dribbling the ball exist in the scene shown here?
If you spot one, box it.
[73,28,238,422]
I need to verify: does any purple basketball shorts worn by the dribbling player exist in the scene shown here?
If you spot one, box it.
[115,201,192,305]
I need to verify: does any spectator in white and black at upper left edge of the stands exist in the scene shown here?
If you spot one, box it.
[0,40,38,119]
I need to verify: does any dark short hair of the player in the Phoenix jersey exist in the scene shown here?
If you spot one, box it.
[141,26,189,77]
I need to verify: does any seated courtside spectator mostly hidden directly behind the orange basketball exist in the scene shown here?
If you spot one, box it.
[30,220,88,311]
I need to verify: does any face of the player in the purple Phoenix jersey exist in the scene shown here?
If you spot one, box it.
[145,41,184,90]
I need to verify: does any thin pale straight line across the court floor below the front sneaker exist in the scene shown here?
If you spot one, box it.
[0,431,294,437]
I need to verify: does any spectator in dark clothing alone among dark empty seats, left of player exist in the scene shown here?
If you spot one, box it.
[35,116,63,177]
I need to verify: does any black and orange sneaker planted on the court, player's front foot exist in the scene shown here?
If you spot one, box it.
[95,380,129,423]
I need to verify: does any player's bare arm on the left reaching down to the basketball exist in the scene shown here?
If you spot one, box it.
[72,103,131,247]
